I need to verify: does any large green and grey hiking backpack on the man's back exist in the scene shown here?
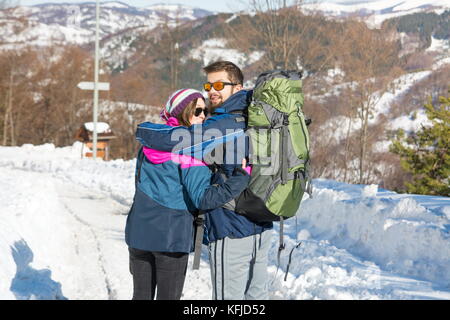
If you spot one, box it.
[235,70,311,222]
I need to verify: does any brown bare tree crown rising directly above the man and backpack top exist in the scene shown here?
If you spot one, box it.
[225,0,340,71]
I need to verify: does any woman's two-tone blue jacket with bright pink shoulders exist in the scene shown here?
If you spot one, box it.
[125,148,250,253]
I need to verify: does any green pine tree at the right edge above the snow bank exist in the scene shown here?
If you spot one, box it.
[390,90,450,196]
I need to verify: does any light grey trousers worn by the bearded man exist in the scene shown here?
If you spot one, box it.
[208,230,272,300]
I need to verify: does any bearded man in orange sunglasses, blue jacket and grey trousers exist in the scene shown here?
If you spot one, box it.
[136,61,273,300]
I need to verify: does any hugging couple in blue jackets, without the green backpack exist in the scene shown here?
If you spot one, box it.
[125,61,273,300]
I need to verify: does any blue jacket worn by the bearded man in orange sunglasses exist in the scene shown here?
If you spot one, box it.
[136,90,273,243]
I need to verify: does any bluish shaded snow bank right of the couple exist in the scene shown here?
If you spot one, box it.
[299,180,450,287]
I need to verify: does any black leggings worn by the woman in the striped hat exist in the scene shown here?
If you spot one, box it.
[128,248,189,300]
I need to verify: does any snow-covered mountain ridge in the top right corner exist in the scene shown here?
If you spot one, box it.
[304,0,450,27]
